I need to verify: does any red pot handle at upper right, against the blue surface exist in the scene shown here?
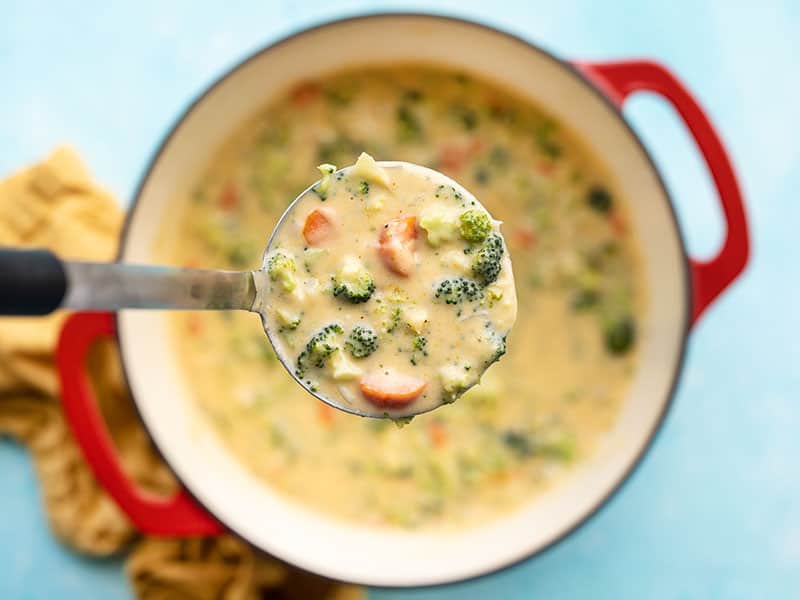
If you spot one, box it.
[573,60,750,324]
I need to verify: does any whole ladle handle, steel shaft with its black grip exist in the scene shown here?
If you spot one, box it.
[0,248,256,315]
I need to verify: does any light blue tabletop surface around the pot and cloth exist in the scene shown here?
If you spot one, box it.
[0,0,800,600]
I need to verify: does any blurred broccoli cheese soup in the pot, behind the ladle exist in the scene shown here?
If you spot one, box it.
[158,66,647,529]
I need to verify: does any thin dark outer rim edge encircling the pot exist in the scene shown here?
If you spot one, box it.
[114,11,692,589]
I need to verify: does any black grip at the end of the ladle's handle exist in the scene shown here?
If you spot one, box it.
[0,248,67,315]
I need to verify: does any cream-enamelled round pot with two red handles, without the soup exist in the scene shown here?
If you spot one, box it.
[58,15,748,586]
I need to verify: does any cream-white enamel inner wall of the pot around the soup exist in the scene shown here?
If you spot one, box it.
[119,16,688,586]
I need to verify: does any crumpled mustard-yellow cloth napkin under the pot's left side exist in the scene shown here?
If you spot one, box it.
[0,148,363,600]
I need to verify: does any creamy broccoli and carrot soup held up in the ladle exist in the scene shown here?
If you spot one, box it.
[257,153,517,418]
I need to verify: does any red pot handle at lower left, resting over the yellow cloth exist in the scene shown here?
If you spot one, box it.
[56,313,223,536]
